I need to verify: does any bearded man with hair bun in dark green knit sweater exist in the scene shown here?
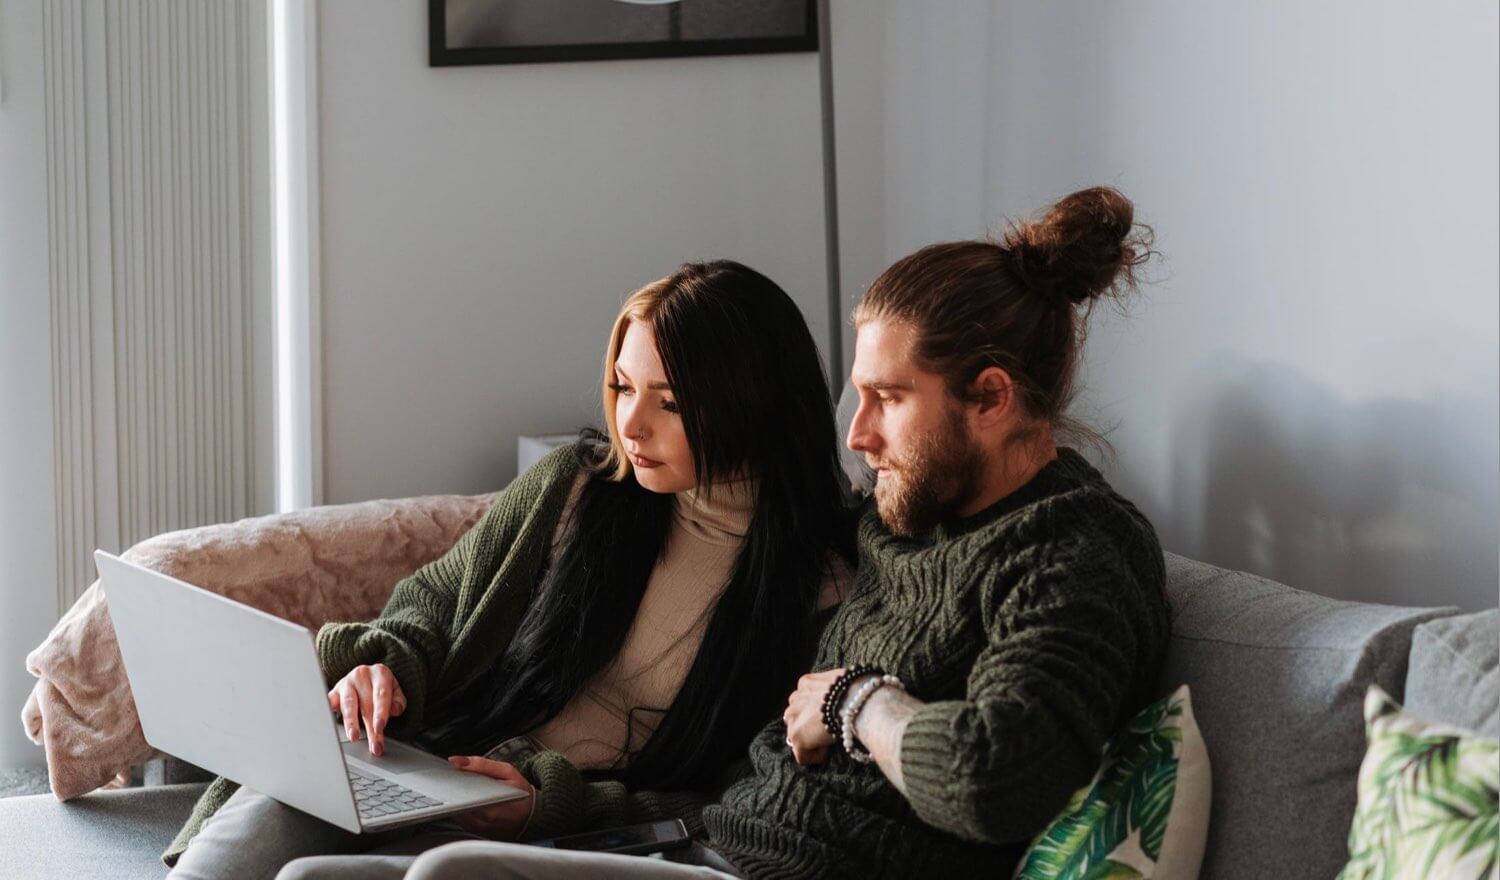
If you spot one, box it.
[704,189,1169,877]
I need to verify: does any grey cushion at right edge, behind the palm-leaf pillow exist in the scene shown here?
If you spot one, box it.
[1406,609,1500,739]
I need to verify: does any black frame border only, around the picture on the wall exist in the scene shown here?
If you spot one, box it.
[428,0,819,67]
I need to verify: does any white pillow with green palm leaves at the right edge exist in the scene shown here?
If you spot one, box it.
[1340,685,1500,880]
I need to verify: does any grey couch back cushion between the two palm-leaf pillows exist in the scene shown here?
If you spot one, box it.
[1160,553,1457,879]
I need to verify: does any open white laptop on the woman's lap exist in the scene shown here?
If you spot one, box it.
[95,550,525,834]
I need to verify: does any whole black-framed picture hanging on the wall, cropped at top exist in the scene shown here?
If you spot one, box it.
[428,0,818,67]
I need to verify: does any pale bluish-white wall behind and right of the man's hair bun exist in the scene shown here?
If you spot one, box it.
[885,0,1500,609]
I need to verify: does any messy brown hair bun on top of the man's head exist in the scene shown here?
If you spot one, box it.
[1001,186,1152,304]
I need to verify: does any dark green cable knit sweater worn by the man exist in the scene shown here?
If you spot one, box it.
[704,448,1169,880]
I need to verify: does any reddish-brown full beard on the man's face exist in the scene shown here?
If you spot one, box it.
[875,408,984,538]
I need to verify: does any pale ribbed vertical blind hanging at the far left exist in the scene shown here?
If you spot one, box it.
[42,0,275,610]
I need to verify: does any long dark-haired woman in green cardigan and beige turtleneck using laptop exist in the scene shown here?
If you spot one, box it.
[165,261,852,877]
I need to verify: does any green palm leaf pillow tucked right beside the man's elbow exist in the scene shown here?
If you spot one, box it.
[1016,685,1211,880]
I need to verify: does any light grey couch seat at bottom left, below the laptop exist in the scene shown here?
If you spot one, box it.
[0,784,204,880]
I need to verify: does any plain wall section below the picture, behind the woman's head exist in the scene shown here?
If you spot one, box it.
[318,0,828,504]
